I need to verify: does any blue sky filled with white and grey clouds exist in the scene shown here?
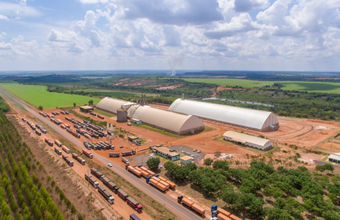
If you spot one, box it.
[0,0,340,71]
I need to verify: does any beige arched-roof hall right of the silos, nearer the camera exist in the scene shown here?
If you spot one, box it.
[128,106,205,134]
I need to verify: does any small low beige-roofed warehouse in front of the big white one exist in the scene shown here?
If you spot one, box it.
[223,131,273,150]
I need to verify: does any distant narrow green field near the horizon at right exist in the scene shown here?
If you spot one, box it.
[182,78,340,94]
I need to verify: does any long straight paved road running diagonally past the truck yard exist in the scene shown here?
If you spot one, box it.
[0,89,200,220]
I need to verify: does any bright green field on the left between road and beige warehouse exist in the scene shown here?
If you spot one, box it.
[0,83,100,109]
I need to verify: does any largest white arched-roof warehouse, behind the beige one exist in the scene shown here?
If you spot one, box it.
[169,99,279,131]
